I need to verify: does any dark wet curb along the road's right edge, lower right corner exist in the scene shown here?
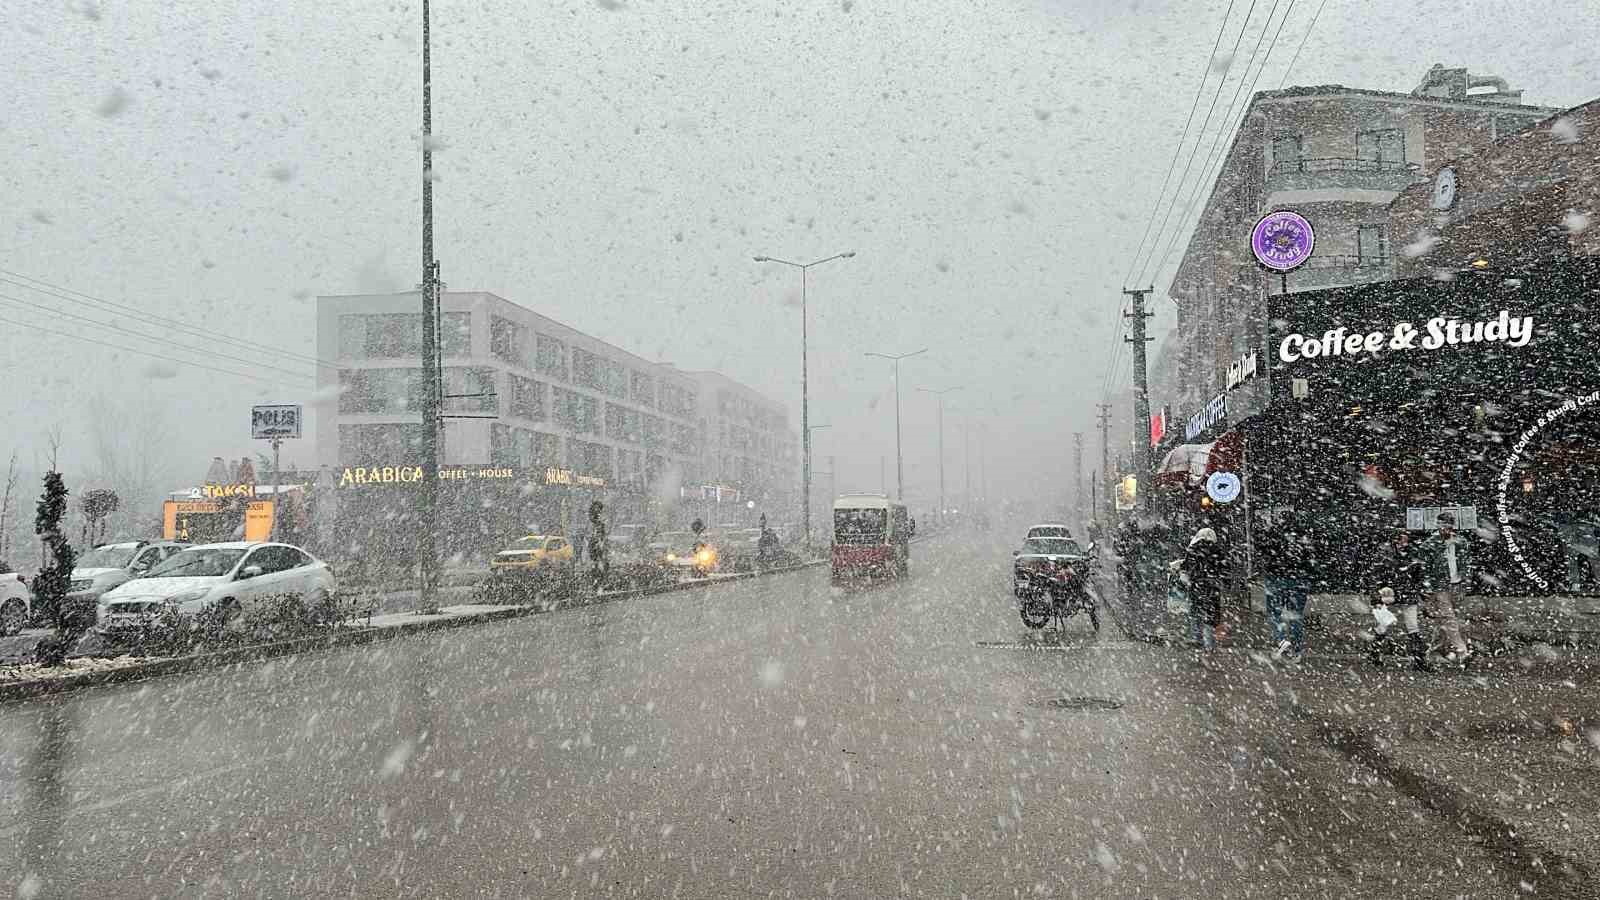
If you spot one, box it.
[1296,706,1597,897]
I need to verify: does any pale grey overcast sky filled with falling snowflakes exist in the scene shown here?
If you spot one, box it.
[0,0,1600,506]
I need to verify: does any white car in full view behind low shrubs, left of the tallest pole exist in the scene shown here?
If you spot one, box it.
[94,541,338,633]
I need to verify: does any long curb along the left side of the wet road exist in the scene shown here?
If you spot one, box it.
[0,560,826,705]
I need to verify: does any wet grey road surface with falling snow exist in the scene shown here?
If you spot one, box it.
[0,538,1515,897]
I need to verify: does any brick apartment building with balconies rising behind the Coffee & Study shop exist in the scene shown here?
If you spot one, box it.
[1152,66,1555,428]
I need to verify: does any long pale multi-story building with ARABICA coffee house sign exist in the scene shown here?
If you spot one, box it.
[314,291,787,543]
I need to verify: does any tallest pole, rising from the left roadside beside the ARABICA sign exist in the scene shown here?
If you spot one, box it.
[418,0,440,613]
